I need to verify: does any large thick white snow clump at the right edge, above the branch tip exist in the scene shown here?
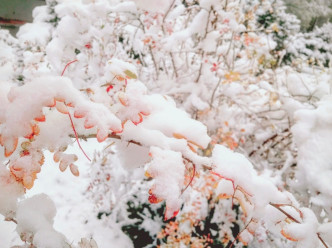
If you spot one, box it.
[292,96,332,214]
